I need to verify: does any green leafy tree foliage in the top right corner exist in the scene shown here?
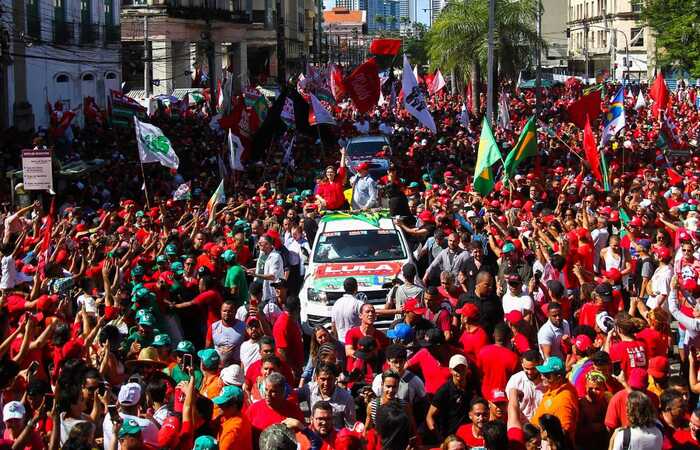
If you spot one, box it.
[643,0,700,77]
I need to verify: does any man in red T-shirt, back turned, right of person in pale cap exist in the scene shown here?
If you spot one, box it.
[476,322,519,397]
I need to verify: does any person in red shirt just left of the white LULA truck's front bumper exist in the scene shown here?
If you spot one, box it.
[272,295,304,376]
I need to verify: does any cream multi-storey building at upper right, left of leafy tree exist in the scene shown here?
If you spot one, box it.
[567,0,654,81]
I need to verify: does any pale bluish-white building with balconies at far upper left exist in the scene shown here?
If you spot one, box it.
[0,0,122,130]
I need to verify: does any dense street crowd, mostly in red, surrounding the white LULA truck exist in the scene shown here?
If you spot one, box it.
[0,71,700,450]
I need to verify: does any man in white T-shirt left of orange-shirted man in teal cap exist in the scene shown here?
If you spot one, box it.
[506,350,545,423]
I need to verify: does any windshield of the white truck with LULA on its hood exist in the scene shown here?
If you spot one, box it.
[313,230,406,263]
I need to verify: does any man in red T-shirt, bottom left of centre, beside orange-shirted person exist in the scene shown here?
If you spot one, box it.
[246,372,304,449]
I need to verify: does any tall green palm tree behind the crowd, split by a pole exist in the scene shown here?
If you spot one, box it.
[428,0,544,111]
